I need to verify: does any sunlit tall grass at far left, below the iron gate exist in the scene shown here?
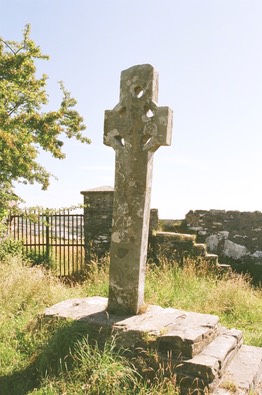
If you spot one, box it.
[0,256,83,386]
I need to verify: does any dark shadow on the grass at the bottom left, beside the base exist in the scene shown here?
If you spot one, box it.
[0,320,92,395]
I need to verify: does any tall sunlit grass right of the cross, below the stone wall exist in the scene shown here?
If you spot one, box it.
[145,259,262,347]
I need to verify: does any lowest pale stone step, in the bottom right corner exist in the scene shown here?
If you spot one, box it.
[214,345,262,395]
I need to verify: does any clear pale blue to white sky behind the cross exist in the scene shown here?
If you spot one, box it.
[0,0,262,219]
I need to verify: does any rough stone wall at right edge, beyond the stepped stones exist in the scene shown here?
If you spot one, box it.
[183,210,262,281]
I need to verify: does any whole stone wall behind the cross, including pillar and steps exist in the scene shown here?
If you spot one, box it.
[81,187,262,282]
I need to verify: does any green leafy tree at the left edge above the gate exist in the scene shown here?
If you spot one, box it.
[0,25,90,216]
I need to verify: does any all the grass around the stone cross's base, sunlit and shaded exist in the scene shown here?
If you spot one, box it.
[0,257,262,395]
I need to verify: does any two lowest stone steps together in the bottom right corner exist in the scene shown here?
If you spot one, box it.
[170,328,262,395]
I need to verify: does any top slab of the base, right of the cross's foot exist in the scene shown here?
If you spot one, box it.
[113,305,221,360]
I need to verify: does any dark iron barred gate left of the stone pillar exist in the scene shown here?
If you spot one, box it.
[8,210,85,276]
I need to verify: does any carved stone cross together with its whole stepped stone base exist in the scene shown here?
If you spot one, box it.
[45,65,262,395]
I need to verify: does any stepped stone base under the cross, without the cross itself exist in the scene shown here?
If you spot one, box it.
[45,297,262,395]
